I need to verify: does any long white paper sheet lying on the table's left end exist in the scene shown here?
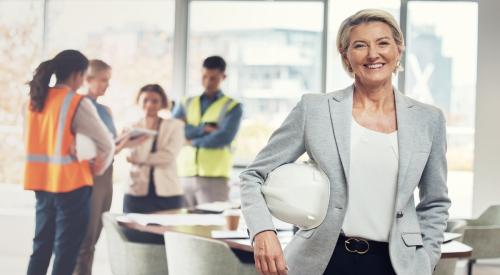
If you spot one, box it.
[125,213,226,226]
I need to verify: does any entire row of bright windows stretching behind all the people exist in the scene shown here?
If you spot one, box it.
[0,0,478,216]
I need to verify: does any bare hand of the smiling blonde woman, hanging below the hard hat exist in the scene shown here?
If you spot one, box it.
[254,231,288,275]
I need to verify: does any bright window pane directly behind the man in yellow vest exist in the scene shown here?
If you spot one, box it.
[187,1,323,164]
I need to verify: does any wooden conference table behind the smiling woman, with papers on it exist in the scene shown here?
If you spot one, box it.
[117,209,472,259]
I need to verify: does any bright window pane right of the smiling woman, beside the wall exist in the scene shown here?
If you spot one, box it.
[405,1,478,216]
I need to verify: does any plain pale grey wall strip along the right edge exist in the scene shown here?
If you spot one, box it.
[472,0,500,216]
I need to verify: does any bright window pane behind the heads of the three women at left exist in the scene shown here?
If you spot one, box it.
[45,0,175,182]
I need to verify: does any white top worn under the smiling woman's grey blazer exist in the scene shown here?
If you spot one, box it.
[342,118,399,242]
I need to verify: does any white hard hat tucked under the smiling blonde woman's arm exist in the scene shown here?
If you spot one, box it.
[262,161,330,230]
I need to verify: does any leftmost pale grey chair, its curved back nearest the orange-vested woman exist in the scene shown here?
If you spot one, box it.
[102,212,168,275]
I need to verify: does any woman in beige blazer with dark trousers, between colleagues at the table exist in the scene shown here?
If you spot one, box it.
[123,84,184,213]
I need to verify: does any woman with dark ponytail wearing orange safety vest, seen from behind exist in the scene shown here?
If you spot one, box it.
[24,50,115,275]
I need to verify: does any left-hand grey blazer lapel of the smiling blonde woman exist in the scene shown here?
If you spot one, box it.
[328,86,353,182]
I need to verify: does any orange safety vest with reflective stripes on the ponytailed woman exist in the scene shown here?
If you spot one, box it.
[24,86,93,193]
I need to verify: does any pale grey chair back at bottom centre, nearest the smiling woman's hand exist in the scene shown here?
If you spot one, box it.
[164,232,257,275]
